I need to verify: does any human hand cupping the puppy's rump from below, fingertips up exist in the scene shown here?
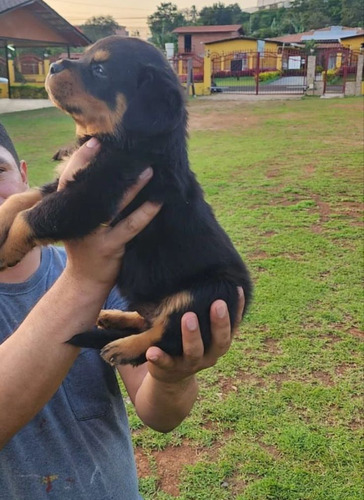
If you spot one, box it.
[146,287,245,384]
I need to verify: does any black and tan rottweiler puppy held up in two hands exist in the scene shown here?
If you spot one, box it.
[0,36,252,365]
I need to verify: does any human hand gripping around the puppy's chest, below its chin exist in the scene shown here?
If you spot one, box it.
[59,138,161,290]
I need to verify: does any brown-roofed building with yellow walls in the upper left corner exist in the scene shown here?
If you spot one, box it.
[0,0,90,97]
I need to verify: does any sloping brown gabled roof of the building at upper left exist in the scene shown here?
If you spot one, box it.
[0,0,91,47]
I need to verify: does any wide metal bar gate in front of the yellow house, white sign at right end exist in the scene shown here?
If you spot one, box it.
[211,50,307,94]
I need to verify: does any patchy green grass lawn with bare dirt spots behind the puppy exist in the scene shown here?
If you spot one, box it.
[1,98,363,500]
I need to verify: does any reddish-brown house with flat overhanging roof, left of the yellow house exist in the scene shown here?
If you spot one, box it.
[173,24,243,57]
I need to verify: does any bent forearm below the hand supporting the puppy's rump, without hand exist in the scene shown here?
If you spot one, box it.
[134,373,198,432]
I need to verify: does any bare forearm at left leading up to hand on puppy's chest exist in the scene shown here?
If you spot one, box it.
[0,271,107,448]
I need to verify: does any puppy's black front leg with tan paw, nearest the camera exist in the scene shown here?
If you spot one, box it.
[0,161,129,269]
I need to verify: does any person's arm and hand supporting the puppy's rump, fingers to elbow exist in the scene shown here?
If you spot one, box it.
[119,288,244,432]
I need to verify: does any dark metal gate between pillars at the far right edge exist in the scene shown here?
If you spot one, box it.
[316,47,358,94]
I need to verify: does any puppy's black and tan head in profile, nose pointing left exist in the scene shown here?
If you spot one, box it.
[46,36,185,138]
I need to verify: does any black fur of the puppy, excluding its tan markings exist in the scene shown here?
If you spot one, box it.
[27,37,252,364]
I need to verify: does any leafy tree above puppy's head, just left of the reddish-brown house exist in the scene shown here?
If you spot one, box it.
[148,2,186,49]
